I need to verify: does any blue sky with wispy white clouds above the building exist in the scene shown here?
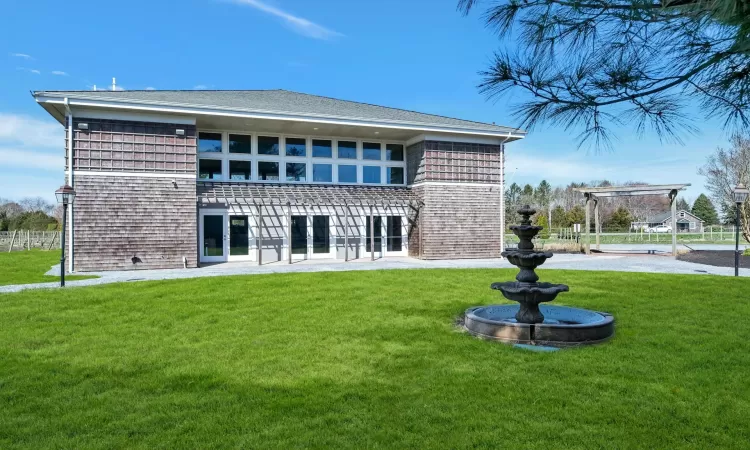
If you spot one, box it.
[0,0,728,201]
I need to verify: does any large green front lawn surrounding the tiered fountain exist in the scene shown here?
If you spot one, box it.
[0,270,750,450]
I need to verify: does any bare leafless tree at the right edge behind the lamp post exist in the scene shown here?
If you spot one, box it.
[698,134,750,240]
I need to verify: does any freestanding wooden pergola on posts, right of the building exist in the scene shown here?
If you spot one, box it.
[574,183,690,256]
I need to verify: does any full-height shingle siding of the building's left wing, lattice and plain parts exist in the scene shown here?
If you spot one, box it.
[66,118,198,272]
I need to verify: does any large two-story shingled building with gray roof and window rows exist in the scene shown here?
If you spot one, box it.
[33,90,525,271]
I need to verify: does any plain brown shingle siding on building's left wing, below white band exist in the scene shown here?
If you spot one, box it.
[73,175,198,272]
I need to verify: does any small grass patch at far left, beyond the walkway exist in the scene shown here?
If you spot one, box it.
[0,250,96,286]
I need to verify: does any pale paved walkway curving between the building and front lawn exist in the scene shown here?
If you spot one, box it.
[0,251,750,293]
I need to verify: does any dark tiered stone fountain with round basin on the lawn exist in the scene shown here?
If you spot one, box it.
[464,205,614,348]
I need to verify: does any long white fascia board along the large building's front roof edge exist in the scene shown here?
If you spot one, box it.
[36,95,526,139]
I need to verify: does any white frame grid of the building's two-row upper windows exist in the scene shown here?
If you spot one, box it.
[198,130,406,186]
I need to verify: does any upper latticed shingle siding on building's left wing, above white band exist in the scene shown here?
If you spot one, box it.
[65,117,196,174]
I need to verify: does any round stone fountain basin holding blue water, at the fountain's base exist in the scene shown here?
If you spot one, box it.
[464,305,615,347]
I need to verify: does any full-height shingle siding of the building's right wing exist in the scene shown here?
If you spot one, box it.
[407,141,502,259]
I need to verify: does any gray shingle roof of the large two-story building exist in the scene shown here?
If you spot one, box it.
[34,89,525,134]
